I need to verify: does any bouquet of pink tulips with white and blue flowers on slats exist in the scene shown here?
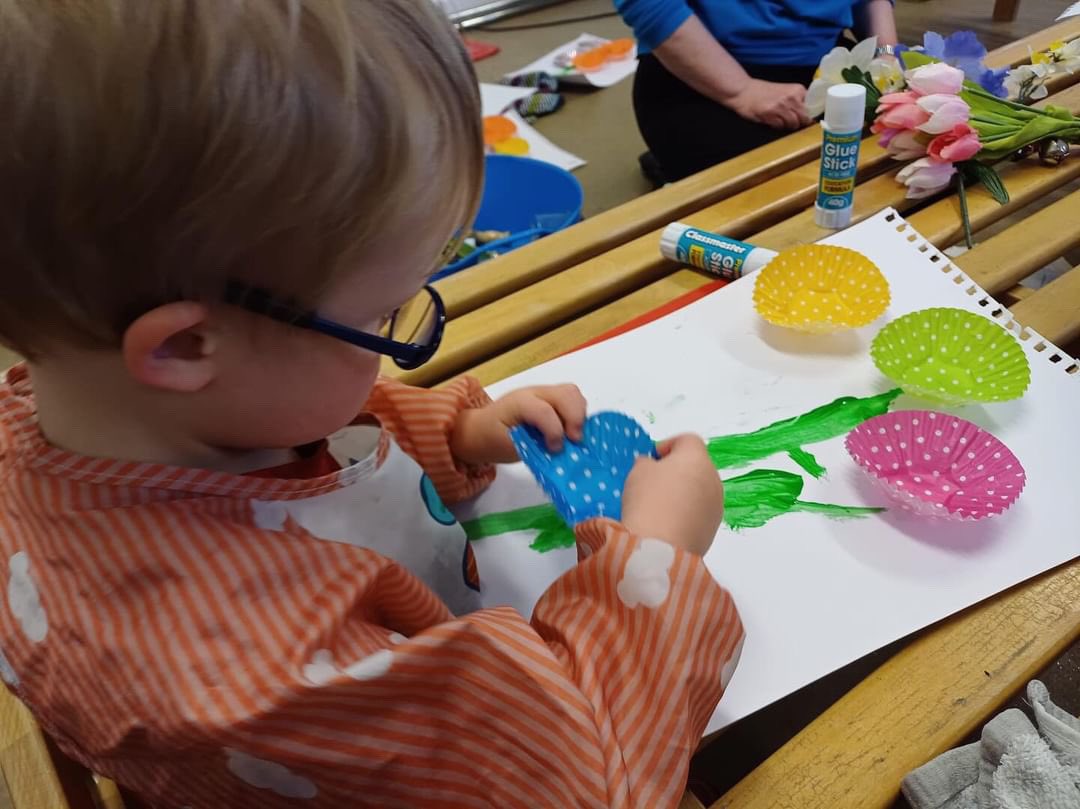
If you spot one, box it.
[807,31,1080,226]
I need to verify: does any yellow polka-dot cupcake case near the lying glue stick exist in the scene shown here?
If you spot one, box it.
[754,244,890,334]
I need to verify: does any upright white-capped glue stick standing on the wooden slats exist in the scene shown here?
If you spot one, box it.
[814,84,866,230]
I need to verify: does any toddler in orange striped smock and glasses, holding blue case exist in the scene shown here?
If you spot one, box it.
[0,0,742,809]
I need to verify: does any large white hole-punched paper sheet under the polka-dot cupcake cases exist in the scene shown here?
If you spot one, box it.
[461,210,1080,731]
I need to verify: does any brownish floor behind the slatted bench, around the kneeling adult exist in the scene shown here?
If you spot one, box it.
[469,0,1067,216]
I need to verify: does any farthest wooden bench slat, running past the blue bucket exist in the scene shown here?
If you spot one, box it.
[437,19,1080,319]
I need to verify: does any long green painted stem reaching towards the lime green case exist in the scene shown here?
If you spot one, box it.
[708,388,903,477]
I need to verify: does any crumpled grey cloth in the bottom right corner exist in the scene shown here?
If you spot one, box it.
[902,679,1080,809]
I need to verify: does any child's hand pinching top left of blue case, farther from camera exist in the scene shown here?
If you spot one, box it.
[450,385,585,464]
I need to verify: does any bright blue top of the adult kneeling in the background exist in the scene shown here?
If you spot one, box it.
[615,0,881,65]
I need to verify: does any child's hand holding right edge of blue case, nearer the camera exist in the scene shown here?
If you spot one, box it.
[622,435,724,556]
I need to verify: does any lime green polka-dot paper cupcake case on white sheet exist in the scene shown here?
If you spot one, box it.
[870,309,1031,404]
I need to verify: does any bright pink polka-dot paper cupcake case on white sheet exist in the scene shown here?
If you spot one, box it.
[845,410,1027,520]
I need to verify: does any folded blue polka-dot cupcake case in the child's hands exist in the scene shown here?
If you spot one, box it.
[510,413,657,525]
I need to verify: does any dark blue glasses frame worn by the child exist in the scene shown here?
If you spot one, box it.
[226,282,446,370]
